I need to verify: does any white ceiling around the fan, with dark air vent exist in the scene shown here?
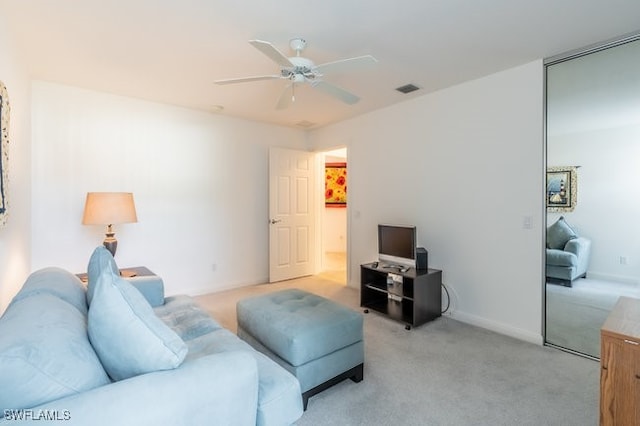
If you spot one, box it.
[0,0,640,127]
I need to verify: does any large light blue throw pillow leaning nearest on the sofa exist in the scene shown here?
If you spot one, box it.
[89,267,187,380]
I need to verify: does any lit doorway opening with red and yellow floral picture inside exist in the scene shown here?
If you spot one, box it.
[318,147,348,285]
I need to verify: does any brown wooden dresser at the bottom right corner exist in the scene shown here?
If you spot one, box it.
[600,297,640,425]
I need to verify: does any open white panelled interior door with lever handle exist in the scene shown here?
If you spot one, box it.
[269,148,315,282]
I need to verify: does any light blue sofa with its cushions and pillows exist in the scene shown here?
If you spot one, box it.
[0,247,303,425]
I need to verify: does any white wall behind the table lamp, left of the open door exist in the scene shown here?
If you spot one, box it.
[32,82,305,294]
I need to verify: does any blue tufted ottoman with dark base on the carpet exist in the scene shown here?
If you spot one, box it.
[237,289,364,409]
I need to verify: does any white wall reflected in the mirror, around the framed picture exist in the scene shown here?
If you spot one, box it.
[547,123,640,283]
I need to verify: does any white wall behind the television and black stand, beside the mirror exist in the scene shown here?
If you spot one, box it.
[309,61,544,343]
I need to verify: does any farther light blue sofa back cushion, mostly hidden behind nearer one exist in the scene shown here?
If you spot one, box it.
[11,267,87,316]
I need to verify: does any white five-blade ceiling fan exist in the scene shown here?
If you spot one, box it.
[215,38,378,109]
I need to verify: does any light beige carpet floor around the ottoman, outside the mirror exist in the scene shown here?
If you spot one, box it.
[197,273,599,426]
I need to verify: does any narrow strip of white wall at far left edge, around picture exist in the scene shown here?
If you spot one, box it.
[0,15,31,314]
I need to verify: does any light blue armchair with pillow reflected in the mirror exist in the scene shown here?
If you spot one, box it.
[546,217,591,287]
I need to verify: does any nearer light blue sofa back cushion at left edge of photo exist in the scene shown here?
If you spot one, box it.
[0,292,110,416]
